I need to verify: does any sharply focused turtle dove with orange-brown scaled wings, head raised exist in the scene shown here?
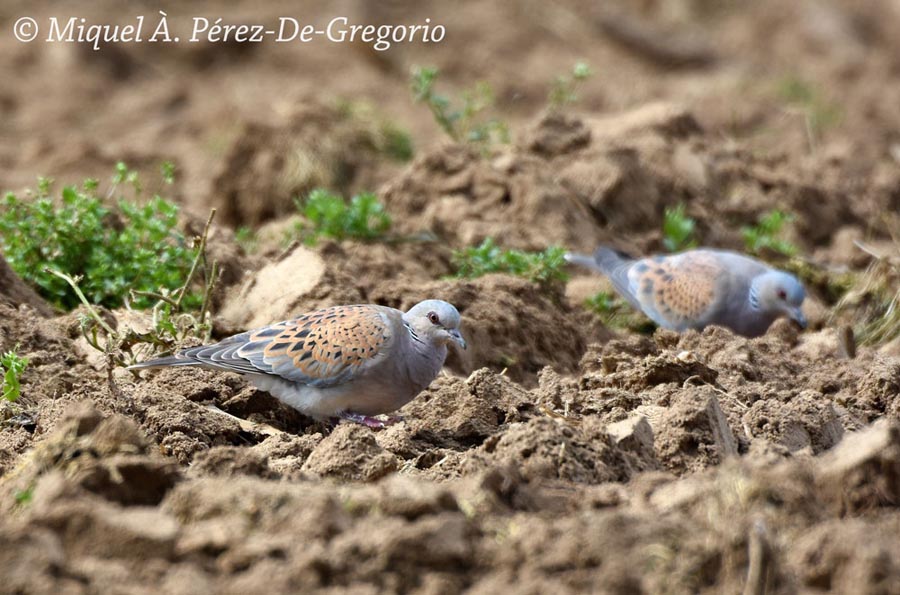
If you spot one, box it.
[129,300,466,427]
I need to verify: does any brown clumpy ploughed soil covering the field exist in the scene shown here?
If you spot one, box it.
[0,0,900,594]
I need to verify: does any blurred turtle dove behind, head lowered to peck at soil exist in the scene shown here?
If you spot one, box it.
[566,246,806,337]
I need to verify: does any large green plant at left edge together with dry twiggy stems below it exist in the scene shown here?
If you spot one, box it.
[0,163,218,370]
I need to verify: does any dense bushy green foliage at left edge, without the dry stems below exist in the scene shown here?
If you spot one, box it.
[0,163,201,310]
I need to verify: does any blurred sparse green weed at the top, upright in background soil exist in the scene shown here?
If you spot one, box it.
[411,67,509,149]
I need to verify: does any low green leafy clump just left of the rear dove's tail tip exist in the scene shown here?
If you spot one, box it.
[452,238,568,287]
